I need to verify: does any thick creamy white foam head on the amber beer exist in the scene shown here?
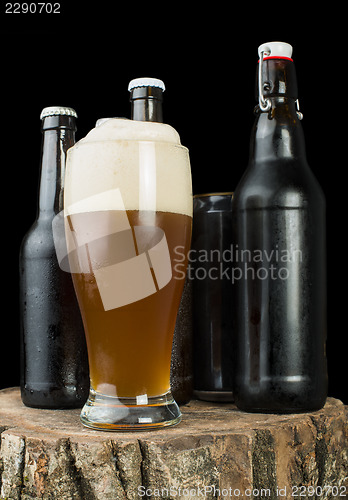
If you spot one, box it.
[64,118,192,216]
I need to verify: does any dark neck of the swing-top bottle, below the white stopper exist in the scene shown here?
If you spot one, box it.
[250,59,306,163]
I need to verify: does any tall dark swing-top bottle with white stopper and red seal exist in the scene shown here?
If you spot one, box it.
[232,42,327,413]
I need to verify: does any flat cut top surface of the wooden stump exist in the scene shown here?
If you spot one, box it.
[0,387,347,442]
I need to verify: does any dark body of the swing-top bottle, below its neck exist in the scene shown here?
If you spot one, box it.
[233,152,327,412]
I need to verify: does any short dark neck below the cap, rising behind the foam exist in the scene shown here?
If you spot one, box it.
[130,87,163,123]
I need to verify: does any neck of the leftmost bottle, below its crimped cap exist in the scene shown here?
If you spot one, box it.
[39,116,76,219]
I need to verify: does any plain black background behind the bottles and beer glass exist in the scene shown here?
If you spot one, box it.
[0,1,348,404]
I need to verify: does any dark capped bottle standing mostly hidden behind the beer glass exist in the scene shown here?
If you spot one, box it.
[128,78,193,405]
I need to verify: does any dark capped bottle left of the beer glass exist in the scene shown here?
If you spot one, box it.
[20,107,89,408]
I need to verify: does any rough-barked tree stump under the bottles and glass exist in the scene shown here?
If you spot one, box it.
[0,388,348,500]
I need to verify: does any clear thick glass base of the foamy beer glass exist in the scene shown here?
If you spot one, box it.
[80,389,181,431]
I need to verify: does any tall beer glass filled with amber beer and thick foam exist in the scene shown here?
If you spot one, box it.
[64,118,192,430]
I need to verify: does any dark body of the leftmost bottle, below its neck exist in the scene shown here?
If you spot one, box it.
[20,220,89,408]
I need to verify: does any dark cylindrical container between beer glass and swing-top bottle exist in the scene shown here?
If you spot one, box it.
[190,192,233,402]
